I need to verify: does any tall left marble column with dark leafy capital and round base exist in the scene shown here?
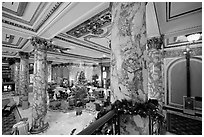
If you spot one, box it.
[30,37,49,134]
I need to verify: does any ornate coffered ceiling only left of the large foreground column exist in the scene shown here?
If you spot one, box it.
[2,2,111,63]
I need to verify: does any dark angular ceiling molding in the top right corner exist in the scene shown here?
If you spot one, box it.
[166,2,202,22]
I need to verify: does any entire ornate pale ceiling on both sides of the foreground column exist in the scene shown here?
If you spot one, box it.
[2,2,202,64]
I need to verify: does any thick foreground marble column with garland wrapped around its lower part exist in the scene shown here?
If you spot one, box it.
[111,2,149,135]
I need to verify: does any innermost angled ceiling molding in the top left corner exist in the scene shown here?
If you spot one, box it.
[2,2,28,17]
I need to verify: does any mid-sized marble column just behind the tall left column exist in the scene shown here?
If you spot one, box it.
[19,52,29,109]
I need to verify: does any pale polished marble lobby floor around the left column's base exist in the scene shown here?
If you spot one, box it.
[13,93,97,135]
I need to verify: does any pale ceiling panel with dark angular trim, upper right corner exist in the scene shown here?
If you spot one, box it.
[154,2,202,37]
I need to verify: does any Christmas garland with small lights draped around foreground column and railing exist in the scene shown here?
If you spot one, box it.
[78,99,164,135]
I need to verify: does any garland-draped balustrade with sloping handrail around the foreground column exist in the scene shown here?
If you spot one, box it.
[78,100,165,135]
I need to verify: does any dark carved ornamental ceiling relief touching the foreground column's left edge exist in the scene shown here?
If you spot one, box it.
[66,8,111,38]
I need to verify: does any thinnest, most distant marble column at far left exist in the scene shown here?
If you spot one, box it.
[13,58,20,96]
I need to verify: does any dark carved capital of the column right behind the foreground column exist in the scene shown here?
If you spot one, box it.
[147,35,163,50]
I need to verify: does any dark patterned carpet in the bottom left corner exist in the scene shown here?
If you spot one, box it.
[2,111,17,135]
